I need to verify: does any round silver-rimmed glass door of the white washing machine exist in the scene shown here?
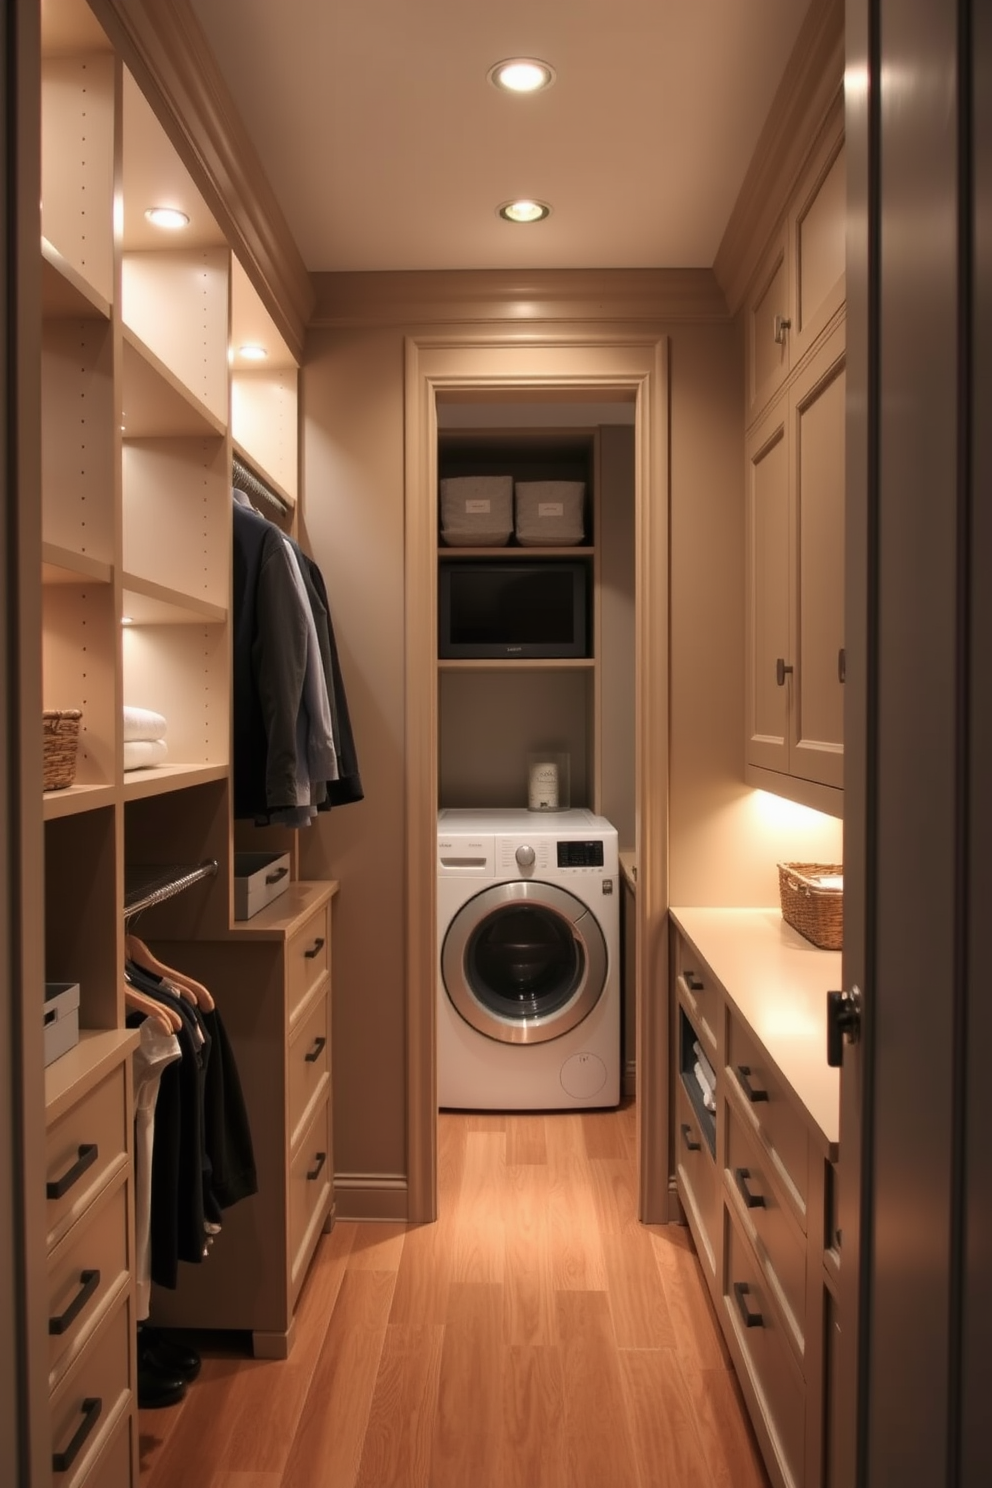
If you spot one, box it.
[440,882,608,1043]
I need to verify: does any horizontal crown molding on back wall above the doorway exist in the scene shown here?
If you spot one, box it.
[311,269,730,327]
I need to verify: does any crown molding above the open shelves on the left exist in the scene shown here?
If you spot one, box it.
[89,0,314,359]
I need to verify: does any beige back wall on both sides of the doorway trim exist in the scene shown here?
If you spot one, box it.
[300,275,839,1213]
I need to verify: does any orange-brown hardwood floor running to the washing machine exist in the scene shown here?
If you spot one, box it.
[140,1106,767,1488]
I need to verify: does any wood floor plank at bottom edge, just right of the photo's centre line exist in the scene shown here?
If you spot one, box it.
[501,1344,571,1488]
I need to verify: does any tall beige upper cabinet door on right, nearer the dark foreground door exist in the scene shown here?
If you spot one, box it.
[791,326,845,786]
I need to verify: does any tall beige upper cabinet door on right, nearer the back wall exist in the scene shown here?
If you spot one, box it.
[747,408,791,771]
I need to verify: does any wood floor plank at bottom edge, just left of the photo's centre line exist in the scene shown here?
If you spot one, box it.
[431,1281,503,1488]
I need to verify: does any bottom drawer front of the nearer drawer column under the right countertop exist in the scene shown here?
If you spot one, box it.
[723,1208,806,1488]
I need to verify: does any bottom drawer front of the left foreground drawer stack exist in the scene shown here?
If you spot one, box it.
[52,1302,131,1488]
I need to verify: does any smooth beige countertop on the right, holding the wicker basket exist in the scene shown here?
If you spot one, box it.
[671,906,842,1156]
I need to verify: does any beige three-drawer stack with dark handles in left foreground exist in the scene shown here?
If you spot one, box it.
[45,1034,137,1488]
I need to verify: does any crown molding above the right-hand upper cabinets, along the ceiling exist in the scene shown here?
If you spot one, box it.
[712,0,845,315]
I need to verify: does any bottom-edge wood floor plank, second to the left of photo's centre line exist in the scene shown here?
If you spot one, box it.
[355,1323,445,1488]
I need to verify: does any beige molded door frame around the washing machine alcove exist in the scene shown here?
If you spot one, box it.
[405,334,669,1223]
